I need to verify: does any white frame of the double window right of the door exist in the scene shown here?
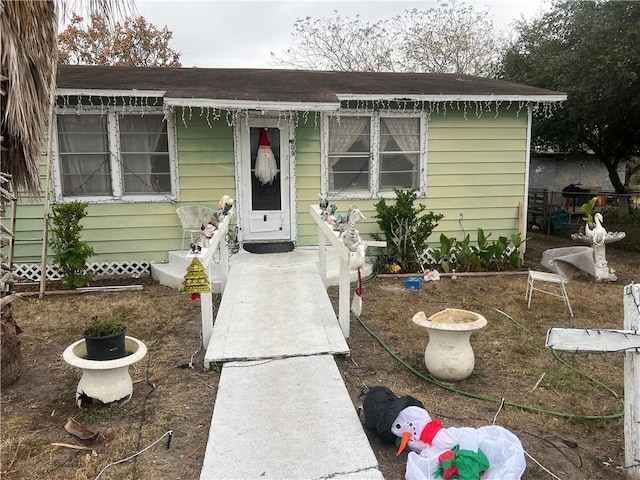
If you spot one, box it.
[320,111,428,199]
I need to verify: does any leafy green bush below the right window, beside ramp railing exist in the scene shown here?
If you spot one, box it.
[372,189,443,272]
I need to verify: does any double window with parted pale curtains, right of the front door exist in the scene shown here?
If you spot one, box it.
[326,113,424,197]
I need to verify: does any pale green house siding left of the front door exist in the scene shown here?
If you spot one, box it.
[3,109,235,264]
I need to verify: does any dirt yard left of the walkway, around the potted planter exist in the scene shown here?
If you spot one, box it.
[1,281,219,480]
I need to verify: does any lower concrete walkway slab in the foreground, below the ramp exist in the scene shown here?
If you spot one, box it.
[200,354,383,480]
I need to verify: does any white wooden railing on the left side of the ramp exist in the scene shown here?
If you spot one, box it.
[187,213,233,348]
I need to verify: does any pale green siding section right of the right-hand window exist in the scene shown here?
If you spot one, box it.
[424,108,528,243]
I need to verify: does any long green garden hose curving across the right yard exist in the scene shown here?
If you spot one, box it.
[351,309,624,420]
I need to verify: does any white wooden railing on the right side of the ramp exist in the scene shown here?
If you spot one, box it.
[310,205,351,338]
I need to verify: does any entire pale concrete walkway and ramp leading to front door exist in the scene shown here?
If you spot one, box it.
[200,252,383,480]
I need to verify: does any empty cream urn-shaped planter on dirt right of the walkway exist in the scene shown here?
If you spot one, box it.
[413,308,487,382]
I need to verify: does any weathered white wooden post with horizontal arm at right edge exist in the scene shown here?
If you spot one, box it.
[547,283,640,480]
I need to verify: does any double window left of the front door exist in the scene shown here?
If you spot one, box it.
[56,111,175,201]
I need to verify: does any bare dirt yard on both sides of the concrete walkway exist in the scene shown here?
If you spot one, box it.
[0,231,640,480]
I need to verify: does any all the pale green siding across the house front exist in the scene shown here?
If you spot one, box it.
[3,104,528,263]
